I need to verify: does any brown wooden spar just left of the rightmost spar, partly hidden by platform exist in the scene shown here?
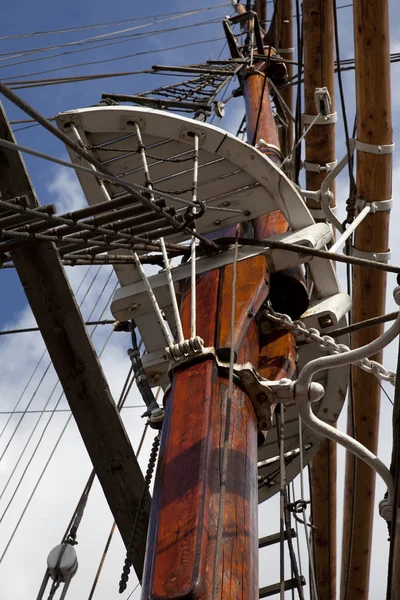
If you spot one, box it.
[303,0,336,600]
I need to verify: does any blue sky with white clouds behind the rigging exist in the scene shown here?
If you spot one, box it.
[0,0,400,600]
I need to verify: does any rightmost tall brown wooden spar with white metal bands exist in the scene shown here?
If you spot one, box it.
[341,0,393,600]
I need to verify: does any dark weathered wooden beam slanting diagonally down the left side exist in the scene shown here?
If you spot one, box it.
[0,107,150,577]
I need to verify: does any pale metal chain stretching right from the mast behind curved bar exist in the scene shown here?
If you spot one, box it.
[266,312,396,385]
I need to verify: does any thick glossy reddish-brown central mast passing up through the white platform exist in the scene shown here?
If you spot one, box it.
[139,8,295,600]
